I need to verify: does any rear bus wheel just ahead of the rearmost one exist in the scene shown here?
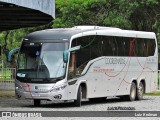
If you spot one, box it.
[127,82,136,101]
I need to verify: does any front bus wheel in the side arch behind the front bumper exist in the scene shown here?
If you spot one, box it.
[74,86,82,107]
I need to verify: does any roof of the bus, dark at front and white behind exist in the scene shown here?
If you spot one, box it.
[25,26,156,42]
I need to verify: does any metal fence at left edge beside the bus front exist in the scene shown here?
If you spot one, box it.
[0,68,16,91]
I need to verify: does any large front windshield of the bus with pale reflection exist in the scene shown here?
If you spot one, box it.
[17,42,68,79]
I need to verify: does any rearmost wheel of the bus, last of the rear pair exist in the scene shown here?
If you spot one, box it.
[136,82,144,100]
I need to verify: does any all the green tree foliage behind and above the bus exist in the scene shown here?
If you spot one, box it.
[0,0,160,66]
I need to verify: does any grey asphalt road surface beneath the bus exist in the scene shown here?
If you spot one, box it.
[0,96,160,120]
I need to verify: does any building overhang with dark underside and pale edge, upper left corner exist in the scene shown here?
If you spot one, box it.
[0,0,55,31]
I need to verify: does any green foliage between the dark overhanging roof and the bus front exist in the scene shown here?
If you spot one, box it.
[0,24,51,68]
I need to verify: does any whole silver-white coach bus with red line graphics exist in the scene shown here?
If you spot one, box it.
[15,26,158,106]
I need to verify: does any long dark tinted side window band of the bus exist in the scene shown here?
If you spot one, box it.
[70,35,156,78]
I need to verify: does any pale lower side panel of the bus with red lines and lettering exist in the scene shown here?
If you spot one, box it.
[84,57,157,98]
